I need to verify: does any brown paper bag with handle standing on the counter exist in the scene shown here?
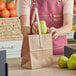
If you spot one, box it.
[21,8,53,69]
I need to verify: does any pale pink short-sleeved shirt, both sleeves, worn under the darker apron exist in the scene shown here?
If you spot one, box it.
[19,0,74,16]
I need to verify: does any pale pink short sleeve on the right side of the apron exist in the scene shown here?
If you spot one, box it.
[63,0,74,14]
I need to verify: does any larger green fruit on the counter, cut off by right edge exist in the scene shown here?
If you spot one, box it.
[67,54,76,70]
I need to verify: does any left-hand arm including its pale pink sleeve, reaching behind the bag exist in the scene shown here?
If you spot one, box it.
[19,0,30,36]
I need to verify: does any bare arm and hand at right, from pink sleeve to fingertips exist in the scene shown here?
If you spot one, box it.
[51,14,73,39]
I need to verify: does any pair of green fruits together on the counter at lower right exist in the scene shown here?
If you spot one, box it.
[58,54,76,70]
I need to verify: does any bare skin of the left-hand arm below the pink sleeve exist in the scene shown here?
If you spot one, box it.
[20,15,30,36]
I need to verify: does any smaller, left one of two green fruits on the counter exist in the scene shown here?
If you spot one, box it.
[58,56,68,68]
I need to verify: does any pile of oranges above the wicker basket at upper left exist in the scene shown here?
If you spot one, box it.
[0,0,17,18]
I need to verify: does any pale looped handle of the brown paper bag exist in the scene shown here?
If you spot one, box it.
[32,8,43,48]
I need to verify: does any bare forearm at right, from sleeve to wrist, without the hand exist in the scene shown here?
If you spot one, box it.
[57,14,73,36]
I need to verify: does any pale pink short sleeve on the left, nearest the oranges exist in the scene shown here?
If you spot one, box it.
[19,0,31,16]
